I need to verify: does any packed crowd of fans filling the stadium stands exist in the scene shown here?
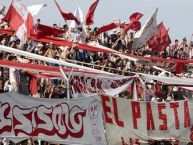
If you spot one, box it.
[0,6,193,101]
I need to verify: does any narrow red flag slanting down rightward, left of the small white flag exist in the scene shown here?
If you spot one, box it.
[54,0,80,25]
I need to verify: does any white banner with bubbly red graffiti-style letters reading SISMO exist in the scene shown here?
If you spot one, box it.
[0,92,106,145]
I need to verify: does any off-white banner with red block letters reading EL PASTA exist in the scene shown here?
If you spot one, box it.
[101,96,193,145]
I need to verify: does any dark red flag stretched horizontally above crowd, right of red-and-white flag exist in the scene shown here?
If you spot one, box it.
[36,24,65,38]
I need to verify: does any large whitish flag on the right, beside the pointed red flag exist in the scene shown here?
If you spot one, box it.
[132,8,158,48]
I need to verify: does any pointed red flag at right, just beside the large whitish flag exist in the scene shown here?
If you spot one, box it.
[147,22,171,51]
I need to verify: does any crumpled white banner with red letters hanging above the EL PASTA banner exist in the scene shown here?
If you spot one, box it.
[68,73,135,97]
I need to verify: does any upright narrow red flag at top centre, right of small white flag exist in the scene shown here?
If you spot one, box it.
[85,0,99,26]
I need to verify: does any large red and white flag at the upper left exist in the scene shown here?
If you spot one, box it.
[4,0,34,42]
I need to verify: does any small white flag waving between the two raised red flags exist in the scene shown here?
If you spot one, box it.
[70,6,84,28]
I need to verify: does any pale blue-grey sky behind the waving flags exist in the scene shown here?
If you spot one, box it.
[0,0,193,40]
